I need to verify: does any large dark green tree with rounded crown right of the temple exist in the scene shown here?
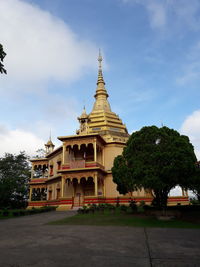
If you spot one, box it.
[112,126,196,207]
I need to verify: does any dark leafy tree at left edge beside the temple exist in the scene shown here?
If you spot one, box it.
[0,152,30,208]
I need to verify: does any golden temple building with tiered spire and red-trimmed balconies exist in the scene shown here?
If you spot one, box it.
[28,54,188,210]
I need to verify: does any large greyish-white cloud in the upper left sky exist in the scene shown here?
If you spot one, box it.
[0,0,97,90]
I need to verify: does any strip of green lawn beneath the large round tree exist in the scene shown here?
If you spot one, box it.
[48,212,200,228]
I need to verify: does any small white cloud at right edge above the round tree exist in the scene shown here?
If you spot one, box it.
[180,110,200,160]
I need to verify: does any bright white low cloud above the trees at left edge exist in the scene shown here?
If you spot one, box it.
[0,125,44,156]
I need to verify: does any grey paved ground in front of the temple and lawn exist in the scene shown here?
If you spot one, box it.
[0,211,200,267]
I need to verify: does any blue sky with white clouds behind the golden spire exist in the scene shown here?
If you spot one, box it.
[0,0,200,160]
